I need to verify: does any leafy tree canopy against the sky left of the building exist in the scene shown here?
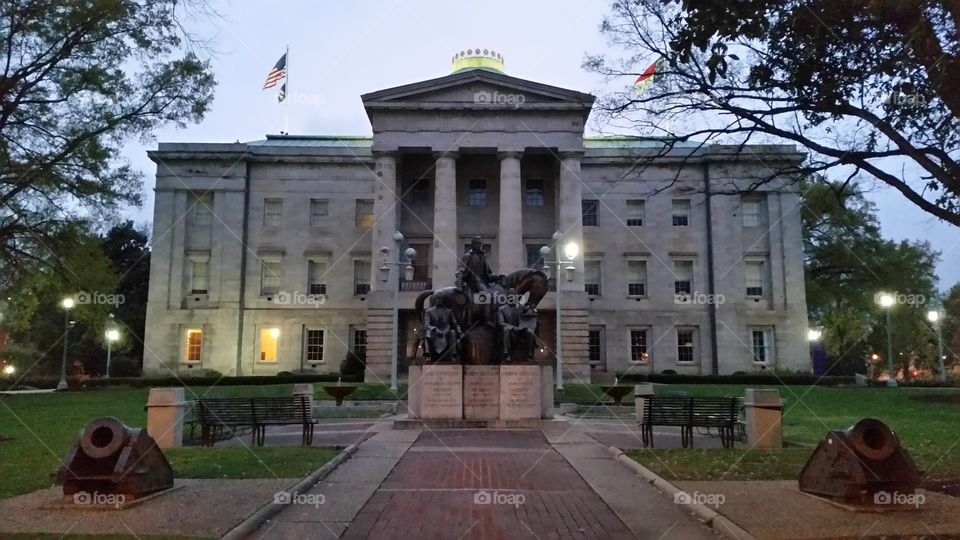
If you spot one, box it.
[0,0,214,295]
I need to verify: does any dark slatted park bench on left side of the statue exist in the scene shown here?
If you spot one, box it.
[196,396,317,446]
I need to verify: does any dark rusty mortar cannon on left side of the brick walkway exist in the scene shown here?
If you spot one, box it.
[57,416,173,502]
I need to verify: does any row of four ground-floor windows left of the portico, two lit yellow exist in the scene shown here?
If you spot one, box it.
[183,326,367,365]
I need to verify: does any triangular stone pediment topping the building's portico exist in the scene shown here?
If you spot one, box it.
[361,69,594,110]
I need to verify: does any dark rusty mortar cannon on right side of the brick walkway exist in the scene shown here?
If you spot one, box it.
[800,418,920,505]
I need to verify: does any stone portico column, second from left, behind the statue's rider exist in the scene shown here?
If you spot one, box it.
[432,152,462,289]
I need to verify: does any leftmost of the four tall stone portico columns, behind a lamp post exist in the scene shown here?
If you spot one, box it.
[370,152,400,290]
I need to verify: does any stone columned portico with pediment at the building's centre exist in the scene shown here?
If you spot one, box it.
[362,59,593,377]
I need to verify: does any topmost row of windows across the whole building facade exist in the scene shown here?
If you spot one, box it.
[193,192,763,228]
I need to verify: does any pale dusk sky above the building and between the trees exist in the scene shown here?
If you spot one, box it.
[127,0,960,289]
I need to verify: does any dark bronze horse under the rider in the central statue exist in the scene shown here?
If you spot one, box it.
[415,268,549,364]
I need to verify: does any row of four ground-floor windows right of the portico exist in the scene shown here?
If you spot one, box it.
[587,326,774,365]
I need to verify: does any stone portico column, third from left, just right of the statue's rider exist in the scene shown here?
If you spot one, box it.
[495,152,526,274]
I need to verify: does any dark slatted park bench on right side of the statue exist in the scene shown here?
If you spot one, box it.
[640,396,739,448]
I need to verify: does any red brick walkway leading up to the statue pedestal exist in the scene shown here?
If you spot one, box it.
[343,431,634,539]
